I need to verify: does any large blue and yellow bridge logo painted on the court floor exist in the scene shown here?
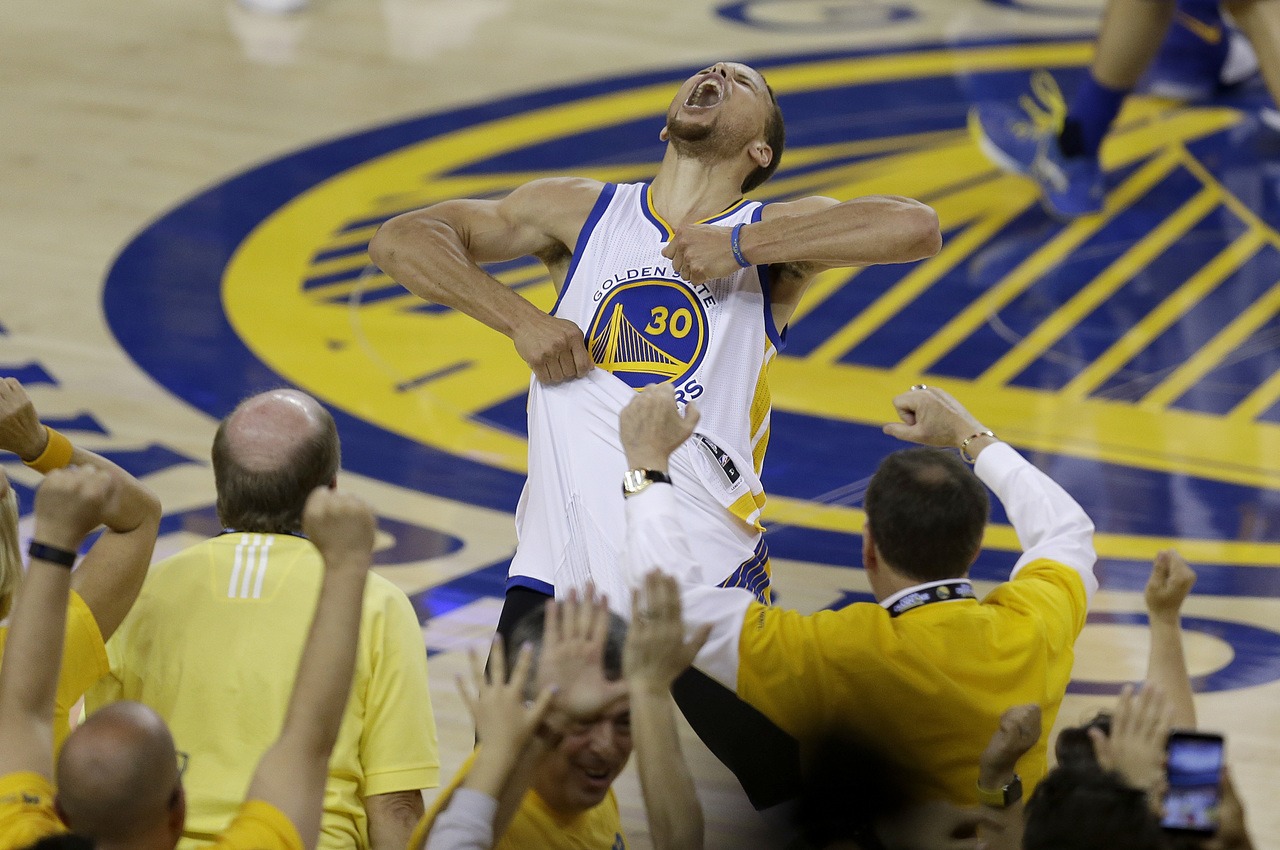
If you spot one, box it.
[104,40,1280,686]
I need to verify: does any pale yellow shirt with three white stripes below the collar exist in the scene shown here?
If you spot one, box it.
[86,533,439,850]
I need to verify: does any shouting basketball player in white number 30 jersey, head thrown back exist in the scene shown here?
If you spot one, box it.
[369,61,941,805]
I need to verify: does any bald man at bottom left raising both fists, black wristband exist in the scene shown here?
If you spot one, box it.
[0,467,375,850]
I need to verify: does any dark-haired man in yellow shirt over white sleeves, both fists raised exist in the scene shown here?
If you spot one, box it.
[620,385,1098,805]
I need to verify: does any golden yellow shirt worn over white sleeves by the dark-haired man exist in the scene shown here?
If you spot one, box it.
[737,559,1087,804]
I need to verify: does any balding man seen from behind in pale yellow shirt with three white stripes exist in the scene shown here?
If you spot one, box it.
[86,389,439,850]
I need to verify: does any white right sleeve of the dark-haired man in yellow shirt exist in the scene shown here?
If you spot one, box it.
[974,443,1098,599]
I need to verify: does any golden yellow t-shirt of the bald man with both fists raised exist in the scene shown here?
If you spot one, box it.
[0,773,303,850]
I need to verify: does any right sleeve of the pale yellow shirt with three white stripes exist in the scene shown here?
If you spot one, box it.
[360,586,440,796]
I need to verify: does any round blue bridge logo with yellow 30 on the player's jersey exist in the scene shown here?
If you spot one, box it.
[586,278,707,389]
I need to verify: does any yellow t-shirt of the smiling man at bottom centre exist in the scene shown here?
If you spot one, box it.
[408,753,627,850]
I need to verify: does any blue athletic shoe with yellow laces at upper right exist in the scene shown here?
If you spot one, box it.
[969,70,1105,219]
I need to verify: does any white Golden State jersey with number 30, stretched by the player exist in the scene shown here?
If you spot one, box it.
[508,183,781,601]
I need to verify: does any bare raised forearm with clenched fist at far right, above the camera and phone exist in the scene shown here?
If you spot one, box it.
[1143,549,1196,728]
